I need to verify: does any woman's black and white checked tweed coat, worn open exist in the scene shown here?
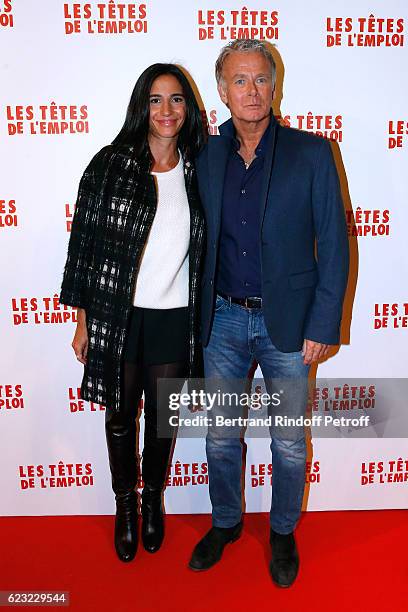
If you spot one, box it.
[60,145,204,410]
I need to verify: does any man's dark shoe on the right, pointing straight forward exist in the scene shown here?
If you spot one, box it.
[269,529,299,587]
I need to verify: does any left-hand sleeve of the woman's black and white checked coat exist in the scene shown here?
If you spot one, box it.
[59,149,108,308]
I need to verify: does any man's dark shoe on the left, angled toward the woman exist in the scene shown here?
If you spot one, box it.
[188,521,242,572]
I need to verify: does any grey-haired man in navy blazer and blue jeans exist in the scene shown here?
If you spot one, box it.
[189,40,348,587]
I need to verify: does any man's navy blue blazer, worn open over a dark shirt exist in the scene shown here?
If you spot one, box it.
[196,115,349,353]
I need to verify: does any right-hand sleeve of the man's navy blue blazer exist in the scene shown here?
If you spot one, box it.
[304,140,349,344]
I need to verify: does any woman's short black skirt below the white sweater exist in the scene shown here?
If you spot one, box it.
[123,306,189,365]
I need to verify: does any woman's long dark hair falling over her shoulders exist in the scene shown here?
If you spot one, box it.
[112,64,205,159]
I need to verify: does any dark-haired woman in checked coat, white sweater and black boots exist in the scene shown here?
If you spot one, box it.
[60,64,204,561]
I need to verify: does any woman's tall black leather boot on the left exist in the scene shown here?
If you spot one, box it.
[105,411,137,561]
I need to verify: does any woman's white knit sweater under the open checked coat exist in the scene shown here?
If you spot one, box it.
[133,155,190,309]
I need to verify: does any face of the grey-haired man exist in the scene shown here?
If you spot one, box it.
[218,51,275,122]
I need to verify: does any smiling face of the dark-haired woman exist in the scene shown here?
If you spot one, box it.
[149,74,187,139]
